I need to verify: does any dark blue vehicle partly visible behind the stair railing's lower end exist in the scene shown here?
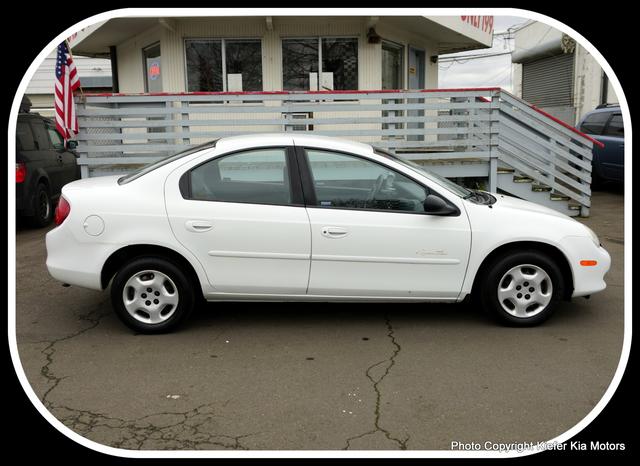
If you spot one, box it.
[578,104,624,186]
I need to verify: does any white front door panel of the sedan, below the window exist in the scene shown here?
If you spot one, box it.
[307,208,471,300]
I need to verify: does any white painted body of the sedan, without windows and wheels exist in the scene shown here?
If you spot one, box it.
[46,134,610,301]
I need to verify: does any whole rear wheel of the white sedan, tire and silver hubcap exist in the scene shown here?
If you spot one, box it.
[111,257,194,333]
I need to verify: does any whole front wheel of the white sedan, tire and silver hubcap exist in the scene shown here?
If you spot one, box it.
[477,251,564,326]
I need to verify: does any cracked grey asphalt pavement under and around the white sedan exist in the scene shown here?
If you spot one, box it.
[16,189,624,450]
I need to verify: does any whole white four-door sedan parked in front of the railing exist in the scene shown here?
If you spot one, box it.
[46,133,610,333]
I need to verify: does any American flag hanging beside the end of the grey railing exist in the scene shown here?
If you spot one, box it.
[55,41,80,141]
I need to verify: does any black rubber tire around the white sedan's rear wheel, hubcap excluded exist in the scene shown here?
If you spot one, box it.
[111,257,195,334]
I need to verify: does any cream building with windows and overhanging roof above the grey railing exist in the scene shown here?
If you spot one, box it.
[71,16,493,93]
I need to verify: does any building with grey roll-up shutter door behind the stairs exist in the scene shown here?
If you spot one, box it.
[512,21,618,125]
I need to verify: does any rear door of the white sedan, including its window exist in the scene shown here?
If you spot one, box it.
[165,147,311,295]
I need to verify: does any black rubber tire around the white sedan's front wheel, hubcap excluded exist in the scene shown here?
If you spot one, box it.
[476,250,565,327]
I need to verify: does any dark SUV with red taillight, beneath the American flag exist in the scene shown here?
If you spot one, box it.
[16,112,80,227]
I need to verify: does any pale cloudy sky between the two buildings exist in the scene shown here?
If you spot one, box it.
[438,16,528,91]
